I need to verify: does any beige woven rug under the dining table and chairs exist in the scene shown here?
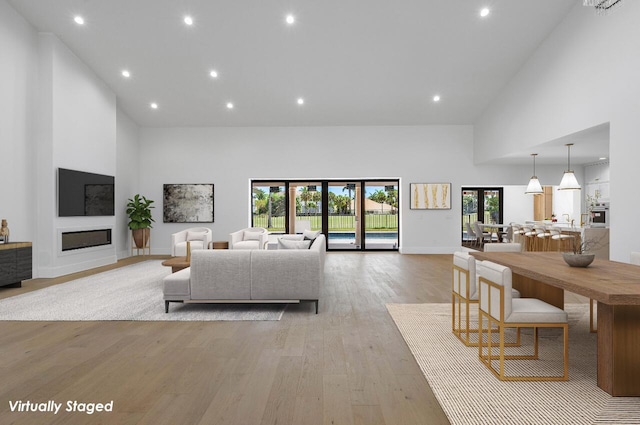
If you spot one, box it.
[387,304,640,425]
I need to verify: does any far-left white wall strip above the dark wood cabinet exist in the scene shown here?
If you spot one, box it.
[0,0,38,245]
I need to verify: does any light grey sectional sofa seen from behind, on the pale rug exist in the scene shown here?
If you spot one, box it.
[163,234,326,314]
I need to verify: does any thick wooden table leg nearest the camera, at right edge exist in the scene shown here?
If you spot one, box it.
[598,302,640,397]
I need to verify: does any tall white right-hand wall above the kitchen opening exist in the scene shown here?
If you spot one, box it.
[475,1,640,261]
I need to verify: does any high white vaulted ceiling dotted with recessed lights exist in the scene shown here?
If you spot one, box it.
[9,0,608,161]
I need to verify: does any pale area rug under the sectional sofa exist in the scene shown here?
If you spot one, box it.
[0,260,286,321]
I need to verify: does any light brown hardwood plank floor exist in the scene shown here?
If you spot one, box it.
[0,253,588,425]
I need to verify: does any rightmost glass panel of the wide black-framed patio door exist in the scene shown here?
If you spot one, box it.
[363,181,398,250]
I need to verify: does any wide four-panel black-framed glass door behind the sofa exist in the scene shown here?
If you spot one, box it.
[251,180,400,251]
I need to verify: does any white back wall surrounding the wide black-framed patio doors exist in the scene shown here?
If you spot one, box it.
[140,126,530,254]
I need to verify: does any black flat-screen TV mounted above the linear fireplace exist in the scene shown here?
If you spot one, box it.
[58,168,115,217]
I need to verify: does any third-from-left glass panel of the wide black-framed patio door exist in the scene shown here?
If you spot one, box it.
[327,181,362,250]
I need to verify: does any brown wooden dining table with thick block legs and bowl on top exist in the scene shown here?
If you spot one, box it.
[470,252,640,396]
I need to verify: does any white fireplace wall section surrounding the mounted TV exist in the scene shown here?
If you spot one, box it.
[34,33,117,277]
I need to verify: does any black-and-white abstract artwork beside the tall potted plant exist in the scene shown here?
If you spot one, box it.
[162,184,213,223]
